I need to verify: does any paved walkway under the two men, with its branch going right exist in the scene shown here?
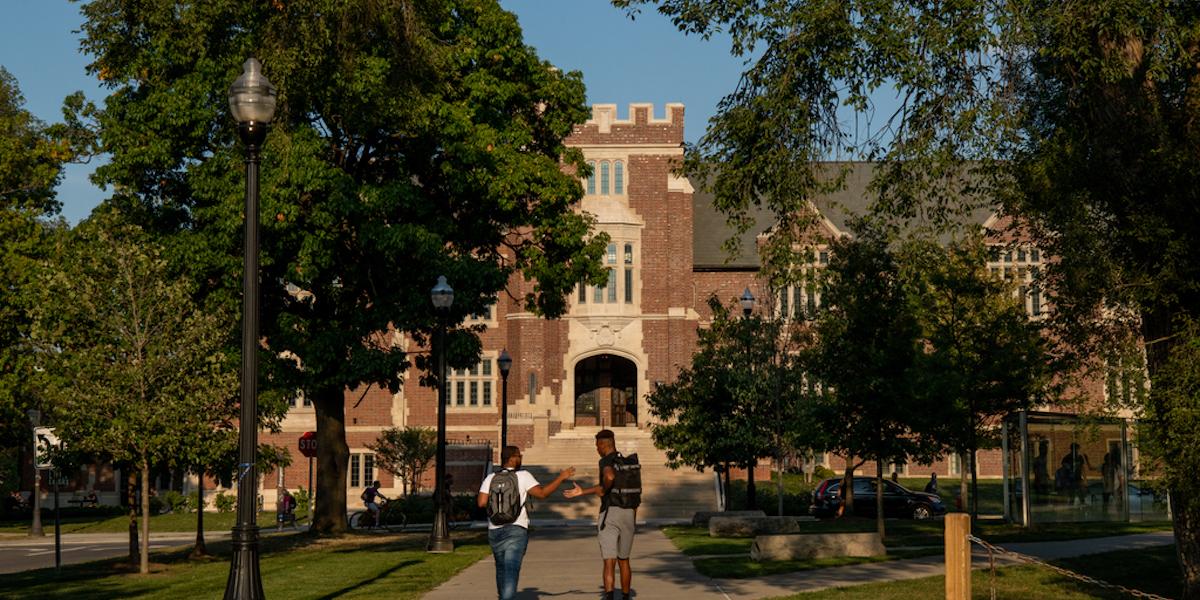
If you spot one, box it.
[424,526,1174,600]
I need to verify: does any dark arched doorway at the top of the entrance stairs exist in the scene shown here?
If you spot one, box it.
[575,354,637,427]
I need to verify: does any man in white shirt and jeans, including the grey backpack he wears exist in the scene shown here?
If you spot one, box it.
[476,446,575,600]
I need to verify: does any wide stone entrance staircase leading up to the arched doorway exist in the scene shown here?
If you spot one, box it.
[522,427,716,521]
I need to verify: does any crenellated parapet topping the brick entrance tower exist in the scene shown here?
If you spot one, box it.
[566,102,684,146]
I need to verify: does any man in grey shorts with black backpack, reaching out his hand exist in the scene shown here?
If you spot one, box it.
[563,430,642,600]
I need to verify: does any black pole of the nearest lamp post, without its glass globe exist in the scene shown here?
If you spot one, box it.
[224,122,266,600]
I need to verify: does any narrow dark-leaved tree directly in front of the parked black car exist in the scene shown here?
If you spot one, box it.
[811,220,941,535]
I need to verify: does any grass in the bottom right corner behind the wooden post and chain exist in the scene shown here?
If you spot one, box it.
[779,546,1182,600]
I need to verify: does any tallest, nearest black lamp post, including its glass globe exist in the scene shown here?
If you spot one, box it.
[224,59,275,600]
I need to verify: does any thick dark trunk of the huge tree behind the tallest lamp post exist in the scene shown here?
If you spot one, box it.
[310,388,350,535]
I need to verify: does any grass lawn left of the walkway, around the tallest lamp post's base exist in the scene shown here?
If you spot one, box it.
[0,533,491,600]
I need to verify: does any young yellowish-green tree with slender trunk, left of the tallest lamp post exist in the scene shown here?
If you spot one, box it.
[34,211,238,572]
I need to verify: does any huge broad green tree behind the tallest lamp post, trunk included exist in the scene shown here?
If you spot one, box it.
[83,0,606,534]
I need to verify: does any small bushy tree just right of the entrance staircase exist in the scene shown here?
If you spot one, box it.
[647,296,802,509]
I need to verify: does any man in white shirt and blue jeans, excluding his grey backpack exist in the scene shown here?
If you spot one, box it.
[476,446,575,600]
